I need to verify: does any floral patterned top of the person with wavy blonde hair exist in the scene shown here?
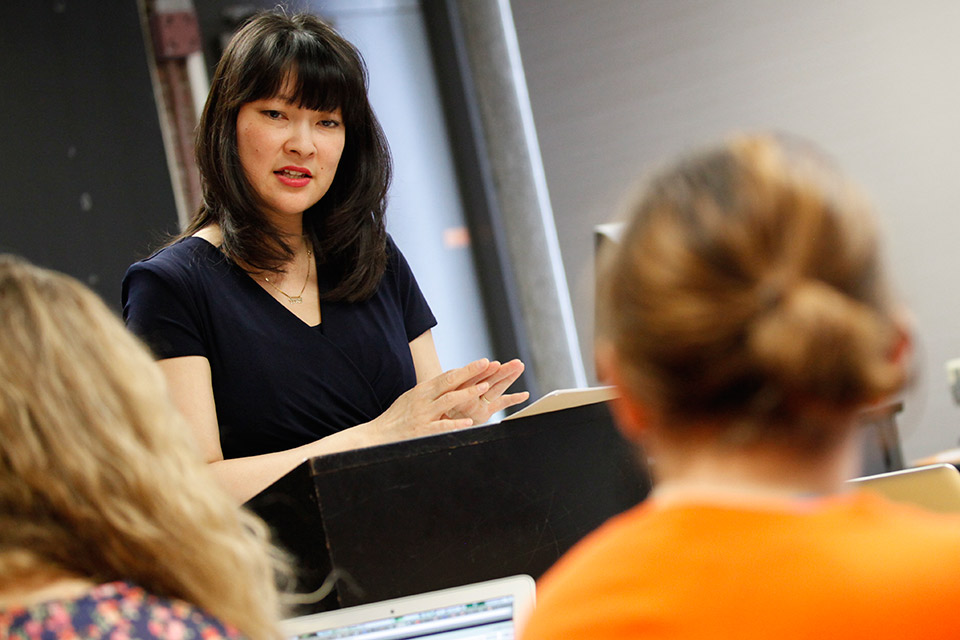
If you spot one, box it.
[0,582,244,640]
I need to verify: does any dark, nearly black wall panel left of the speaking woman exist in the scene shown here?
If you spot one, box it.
[0,0,177,308]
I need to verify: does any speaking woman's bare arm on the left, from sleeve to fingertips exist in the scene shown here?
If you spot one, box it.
[158,356,491,503]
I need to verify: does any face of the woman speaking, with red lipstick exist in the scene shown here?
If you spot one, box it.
[237,87,346,226]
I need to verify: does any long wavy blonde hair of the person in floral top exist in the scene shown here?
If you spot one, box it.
[0,256,282,640]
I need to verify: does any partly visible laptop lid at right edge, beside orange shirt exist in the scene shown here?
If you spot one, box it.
[849,464,960,513]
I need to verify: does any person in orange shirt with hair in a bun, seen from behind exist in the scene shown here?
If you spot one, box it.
[523,135,960,640]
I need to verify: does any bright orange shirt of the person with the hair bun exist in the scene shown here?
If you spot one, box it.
[522,494,960,640]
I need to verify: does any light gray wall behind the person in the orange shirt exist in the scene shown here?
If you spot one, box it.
[512,0,960,458]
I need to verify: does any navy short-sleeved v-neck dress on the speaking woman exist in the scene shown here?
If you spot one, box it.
[122,237,436,459]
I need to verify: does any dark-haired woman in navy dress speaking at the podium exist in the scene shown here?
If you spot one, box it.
[123,8,527,500]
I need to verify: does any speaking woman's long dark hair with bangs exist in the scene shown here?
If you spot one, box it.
[184,12,391,301]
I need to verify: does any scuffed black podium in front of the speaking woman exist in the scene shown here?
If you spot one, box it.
[247,403,650,613]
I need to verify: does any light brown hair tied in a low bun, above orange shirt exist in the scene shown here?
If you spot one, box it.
[598,134,906,449]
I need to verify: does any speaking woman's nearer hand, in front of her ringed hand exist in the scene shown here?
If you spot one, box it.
[356,358,496,446]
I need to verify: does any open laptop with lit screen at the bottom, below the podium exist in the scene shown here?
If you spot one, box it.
[281,575,535,640]
